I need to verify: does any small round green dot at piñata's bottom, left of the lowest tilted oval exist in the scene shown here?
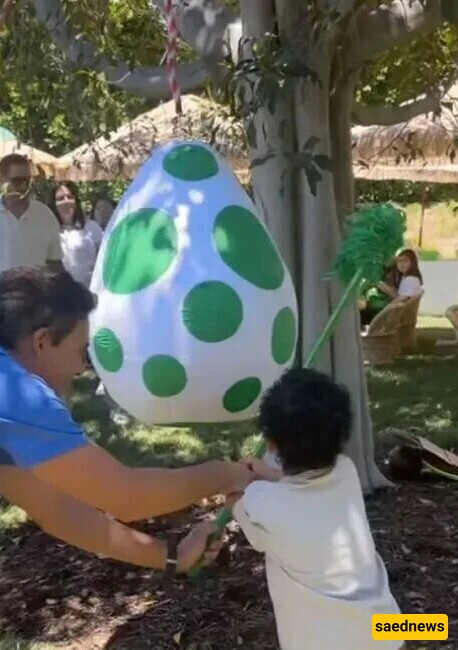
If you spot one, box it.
[143,354,187,397]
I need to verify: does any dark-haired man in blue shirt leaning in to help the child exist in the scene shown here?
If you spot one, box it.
[0,267,256,574]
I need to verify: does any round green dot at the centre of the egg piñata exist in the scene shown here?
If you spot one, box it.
[183,281,243,343]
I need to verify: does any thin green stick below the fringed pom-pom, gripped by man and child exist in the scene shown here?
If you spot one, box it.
[189,268,364,578]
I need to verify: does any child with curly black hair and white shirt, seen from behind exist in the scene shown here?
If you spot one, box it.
[228,368,403,650]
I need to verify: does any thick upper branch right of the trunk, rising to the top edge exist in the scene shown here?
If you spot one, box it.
[345,0,444,64]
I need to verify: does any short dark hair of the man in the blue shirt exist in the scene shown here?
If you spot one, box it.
[0,267,96,350]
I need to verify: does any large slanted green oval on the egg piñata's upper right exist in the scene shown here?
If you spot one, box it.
[213,205,285,290]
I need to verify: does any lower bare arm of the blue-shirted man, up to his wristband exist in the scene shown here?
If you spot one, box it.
[0,467,167,569]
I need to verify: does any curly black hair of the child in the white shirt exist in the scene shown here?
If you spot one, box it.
[259,368,352,474]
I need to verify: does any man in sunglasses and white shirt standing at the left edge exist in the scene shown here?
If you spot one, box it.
[0,153,63,271]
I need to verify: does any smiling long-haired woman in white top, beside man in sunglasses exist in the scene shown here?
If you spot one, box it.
[50,182,103,286]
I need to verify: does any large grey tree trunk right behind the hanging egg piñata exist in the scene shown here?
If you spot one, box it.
[242,0,387,492]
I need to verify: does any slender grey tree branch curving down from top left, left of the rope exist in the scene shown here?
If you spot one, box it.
[31,0,208,100]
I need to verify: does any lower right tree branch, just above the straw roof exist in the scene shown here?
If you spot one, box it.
[352,81,453,126]
